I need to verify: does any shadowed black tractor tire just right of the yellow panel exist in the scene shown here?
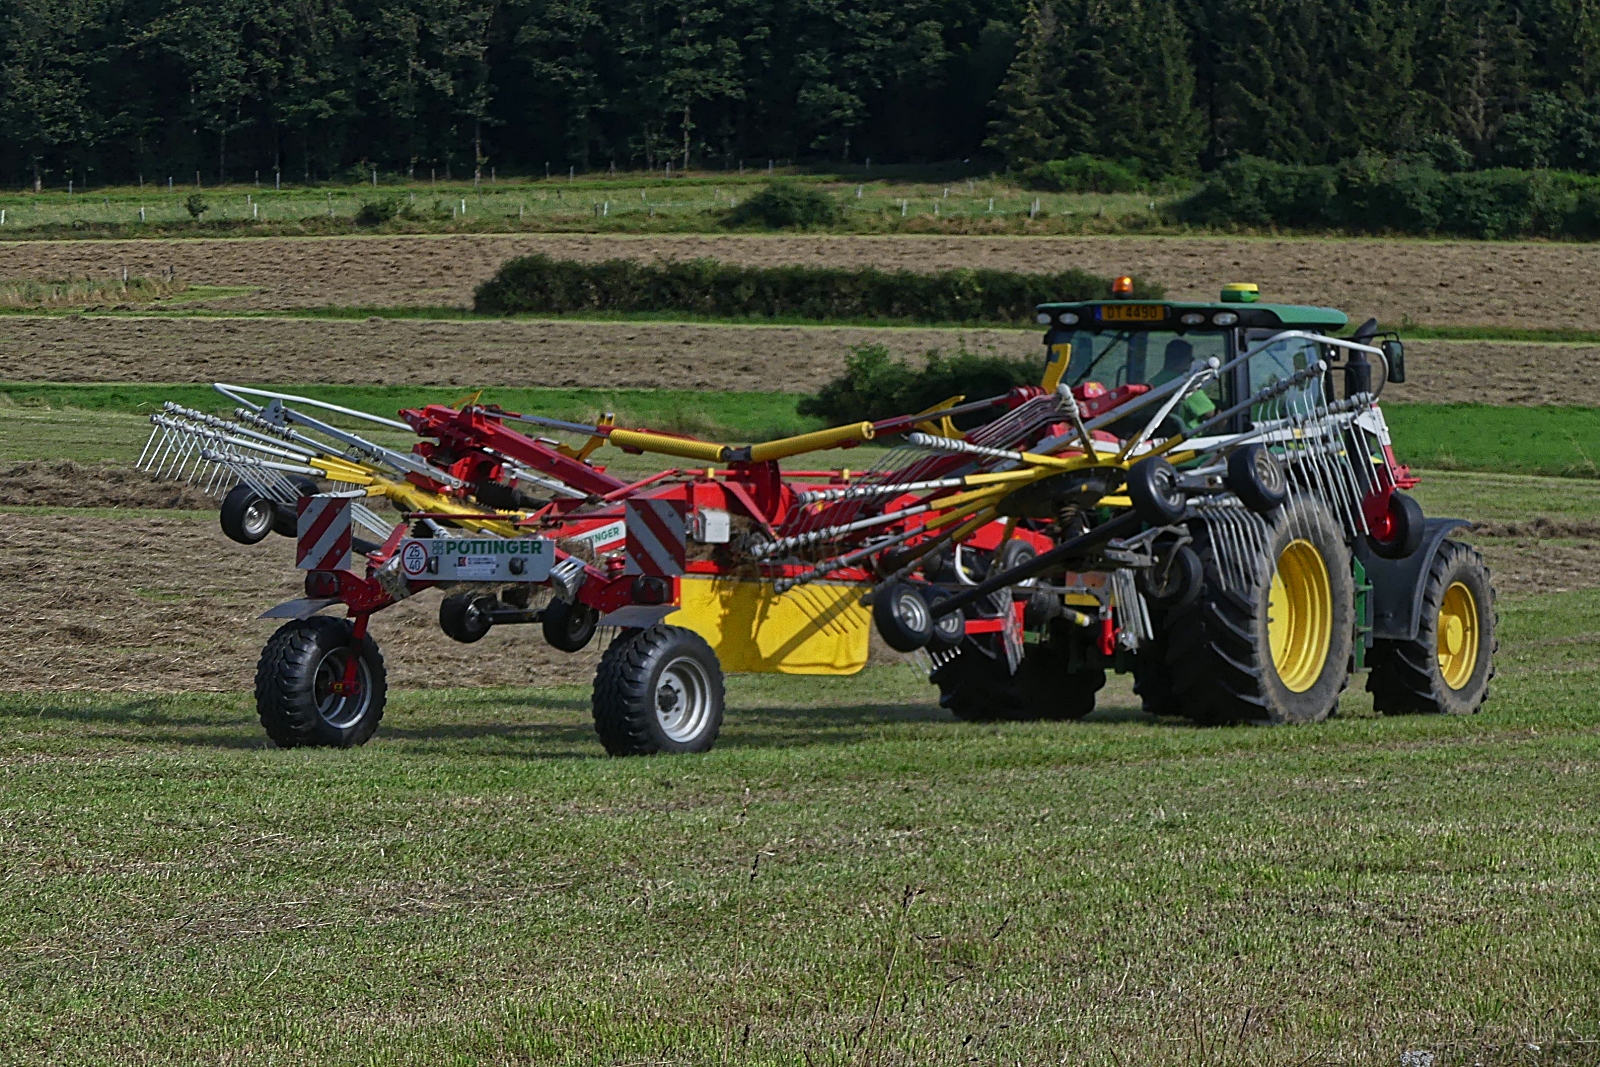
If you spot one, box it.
[930,641,1106,723]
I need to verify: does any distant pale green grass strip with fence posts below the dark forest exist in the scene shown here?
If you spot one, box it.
[0,170,1173,238]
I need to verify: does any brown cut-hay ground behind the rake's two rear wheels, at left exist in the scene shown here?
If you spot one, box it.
[0,512,614,693]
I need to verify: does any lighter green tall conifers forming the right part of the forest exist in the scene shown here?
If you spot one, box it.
[989,0,1600,174]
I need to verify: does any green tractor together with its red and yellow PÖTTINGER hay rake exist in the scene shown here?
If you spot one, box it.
[141,279,1494,755]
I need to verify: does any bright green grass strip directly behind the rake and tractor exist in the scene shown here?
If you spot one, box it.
[12,382,1600,478]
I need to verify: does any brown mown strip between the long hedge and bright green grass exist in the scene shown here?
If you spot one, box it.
[0,315,1580,405]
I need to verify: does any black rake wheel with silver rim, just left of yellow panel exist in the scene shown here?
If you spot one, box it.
[592,622,723,755]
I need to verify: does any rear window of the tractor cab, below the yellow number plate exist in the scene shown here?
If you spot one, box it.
[1056,330,1227,430]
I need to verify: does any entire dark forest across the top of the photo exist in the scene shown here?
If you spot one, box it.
[0,0,1600,186]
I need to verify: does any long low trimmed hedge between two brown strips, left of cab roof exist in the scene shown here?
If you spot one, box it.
[474,256,1163,323]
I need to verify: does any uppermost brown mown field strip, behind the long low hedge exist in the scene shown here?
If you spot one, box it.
[0,235,1600,330]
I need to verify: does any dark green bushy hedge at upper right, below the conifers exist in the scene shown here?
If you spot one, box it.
[1173,157,1600,238]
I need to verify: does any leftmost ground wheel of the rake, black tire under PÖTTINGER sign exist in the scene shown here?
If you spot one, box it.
[256,616,389,749]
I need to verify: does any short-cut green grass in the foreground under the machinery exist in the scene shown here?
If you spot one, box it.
[0,592,1600,1065]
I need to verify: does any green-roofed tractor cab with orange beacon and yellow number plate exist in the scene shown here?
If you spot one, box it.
[1037,278,1349,432]
